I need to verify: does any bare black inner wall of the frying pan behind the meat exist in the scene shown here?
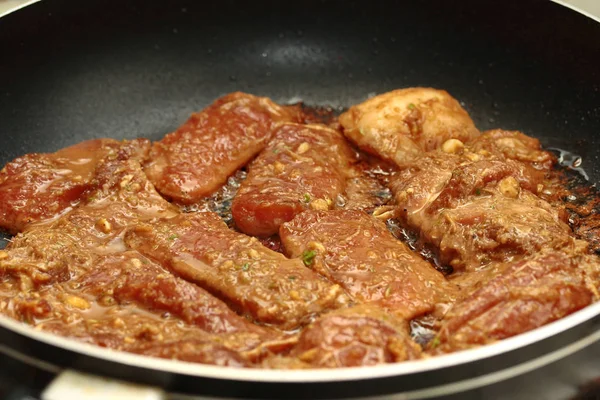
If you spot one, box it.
[0,0,600,172]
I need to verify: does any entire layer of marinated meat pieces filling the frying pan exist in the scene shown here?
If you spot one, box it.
[0,88,600,369]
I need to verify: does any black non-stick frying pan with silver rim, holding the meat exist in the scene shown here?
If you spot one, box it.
[0,0,600,398]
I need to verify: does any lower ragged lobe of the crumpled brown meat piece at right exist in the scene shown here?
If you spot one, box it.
[422,189,581,270]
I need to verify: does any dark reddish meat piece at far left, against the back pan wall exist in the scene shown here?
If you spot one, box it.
[0,139,122,234]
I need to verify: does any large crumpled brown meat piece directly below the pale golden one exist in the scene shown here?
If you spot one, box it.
[390,146,581,271]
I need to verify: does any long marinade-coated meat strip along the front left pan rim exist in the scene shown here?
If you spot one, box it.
[0,285,269,366]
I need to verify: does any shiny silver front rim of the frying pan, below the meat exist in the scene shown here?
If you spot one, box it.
[0,302,600,383]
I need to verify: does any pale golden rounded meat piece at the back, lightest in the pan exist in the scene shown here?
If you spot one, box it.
[340,88,479,167]
